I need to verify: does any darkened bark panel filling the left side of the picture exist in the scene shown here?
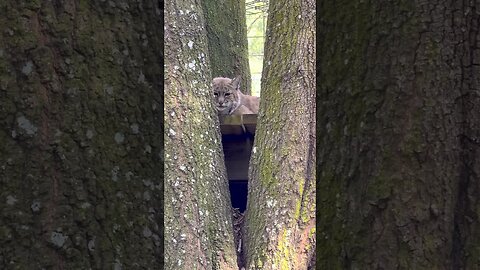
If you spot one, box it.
[0,0,163,269]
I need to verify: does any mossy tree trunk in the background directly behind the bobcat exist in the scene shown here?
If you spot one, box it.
[201,0,252,95]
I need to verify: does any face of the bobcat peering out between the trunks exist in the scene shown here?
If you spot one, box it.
[212,77,239,114]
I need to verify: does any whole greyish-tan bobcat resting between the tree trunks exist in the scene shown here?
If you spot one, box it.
[212,76,260,115]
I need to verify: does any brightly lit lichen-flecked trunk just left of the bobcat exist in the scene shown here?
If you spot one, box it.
[164,0,238,270]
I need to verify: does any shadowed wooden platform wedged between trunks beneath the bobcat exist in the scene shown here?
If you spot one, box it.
[219,114,257,181]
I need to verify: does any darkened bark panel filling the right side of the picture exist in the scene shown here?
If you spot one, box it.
[317,1,480,269]
